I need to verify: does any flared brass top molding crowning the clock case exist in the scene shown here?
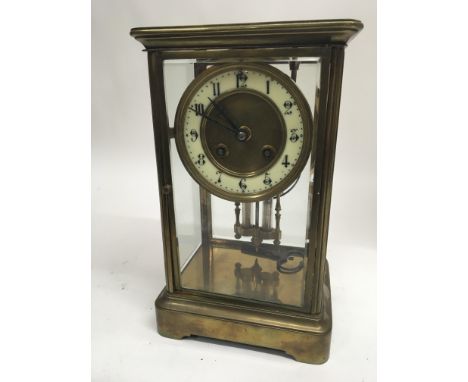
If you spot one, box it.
[130,19,363,50]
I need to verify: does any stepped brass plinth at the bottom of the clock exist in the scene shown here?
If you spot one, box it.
[155,264,332,364]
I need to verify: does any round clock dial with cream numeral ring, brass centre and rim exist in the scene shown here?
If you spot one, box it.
[175,64,312,201]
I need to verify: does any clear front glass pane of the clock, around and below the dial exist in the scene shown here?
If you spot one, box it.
[164,58,320,307]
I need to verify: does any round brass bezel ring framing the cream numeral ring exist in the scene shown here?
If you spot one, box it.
[174,62,314,202]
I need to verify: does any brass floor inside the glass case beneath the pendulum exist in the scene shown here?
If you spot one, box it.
[181,242,307,306]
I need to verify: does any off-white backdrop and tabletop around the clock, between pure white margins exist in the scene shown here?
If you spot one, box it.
[92,0,376,382]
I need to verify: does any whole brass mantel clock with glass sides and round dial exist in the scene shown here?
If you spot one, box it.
[131,20,362,363]
